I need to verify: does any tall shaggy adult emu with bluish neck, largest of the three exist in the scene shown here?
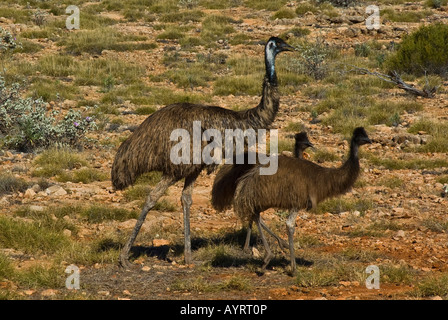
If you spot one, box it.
[111,37,293,267]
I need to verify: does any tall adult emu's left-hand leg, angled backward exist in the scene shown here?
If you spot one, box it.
[119,176,176,269]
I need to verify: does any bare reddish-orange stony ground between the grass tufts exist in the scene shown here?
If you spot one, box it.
[0,1,448,299]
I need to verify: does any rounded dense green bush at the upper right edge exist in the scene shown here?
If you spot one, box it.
[386,23,448,76]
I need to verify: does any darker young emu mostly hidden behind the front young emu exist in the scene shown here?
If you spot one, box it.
[211,132,313,252]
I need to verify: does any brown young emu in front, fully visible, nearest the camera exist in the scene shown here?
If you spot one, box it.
[234,127,371,273]
